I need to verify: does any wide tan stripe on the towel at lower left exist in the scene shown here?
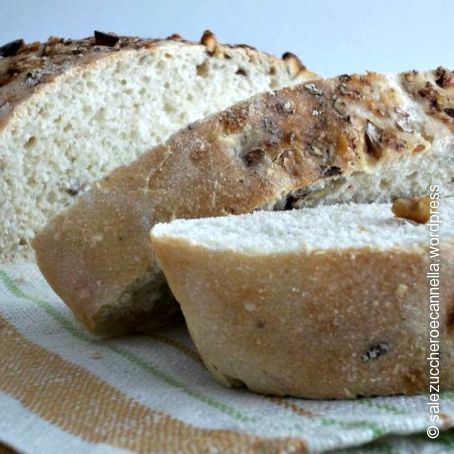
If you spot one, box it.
[0,318,305,453]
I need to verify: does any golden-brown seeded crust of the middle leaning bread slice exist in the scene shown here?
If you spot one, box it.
[34,69,454,336]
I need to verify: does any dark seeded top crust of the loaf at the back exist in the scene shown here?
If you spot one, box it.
[0,31,317,130]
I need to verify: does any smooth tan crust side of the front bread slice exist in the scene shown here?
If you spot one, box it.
[152,235,454,399]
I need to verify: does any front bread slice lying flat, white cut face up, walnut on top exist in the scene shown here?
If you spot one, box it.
[151,199,454,399]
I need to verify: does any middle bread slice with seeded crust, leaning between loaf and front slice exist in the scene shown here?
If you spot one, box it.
[34,69,454,333]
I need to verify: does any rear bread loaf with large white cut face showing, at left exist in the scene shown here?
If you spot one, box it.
[0,32,315,262]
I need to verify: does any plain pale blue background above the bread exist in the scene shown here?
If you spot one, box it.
[0,0,454,76]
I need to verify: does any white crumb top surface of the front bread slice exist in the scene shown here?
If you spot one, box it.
[152,198,454,255]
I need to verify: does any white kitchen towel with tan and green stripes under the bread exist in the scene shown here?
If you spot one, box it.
[0,263,454,453]
